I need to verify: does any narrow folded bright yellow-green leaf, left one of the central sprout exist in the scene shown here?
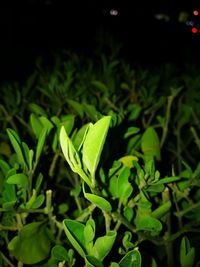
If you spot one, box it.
[60,126,91,187]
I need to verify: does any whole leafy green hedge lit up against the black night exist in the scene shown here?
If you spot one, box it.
[0,49,200,267]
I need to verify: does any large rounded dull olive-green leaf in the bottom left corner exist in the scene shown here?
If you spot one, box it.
[8,222,50,264]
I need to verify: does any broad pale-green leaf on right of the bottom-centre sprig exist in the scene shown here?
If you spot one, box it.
[93,231,117,261]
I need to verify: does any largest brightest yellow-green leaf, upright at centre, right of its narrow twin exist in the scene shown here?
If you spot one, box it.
[83,116,111,177]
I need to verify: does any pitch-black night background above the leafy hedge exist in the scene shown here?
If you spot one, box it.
[0,0,199,79]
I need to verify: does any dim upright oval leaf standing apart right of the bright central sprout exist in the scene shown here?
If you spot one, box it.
[141,127,160,161]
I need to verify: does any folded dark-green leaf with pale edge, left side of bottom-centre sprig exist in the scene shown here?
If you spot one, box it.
[63,219,86,258]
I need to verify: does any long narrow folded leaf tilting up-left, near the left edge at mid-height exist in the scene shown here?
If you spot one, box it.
[7,129,27,167]
